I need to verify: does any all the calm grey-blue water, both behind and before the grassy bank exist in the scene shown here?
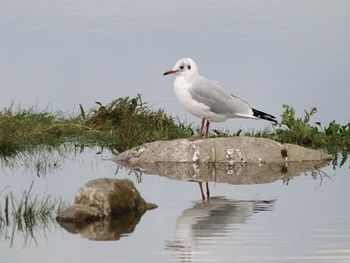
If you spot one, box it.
[0,0,350,263]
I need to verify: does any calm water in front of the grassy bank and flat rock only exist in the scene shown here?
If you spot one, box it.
[0,150,350,262]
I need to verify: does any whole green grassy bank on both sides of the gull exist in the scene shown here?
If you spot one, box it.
[0,96,350,161]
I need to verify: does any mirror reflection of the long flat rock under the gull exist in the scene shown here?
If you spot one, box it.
[117,161,329,185]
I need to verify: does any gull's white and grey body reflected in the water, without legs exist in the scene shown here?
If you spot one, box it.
[167,197,274,262]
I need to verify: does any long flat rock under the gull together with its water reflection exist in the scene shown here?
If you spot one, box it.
[112,137,332,184]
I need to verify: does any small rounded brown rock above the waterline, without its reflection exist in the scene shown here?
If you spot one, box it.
[56,178,157,228]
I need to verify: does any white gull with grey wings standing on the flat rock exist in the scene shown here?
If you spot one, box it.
[163,58,277,138]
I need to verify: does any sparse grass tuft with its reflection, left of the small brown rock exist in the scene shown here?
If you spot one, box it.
[0,183,64,246]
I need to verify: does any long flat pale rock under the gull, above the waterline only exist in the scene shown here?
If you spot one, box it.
[113,137,332,165]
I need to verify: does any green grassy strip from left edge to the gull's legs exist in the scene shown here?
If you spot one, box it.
[0,96,193,156]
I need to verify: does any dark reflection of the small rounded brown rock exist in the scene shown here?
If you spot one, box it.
[59,213,144,240]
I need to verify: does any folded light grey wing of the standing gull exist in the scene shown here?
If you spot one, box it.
[189,76,254,118]
